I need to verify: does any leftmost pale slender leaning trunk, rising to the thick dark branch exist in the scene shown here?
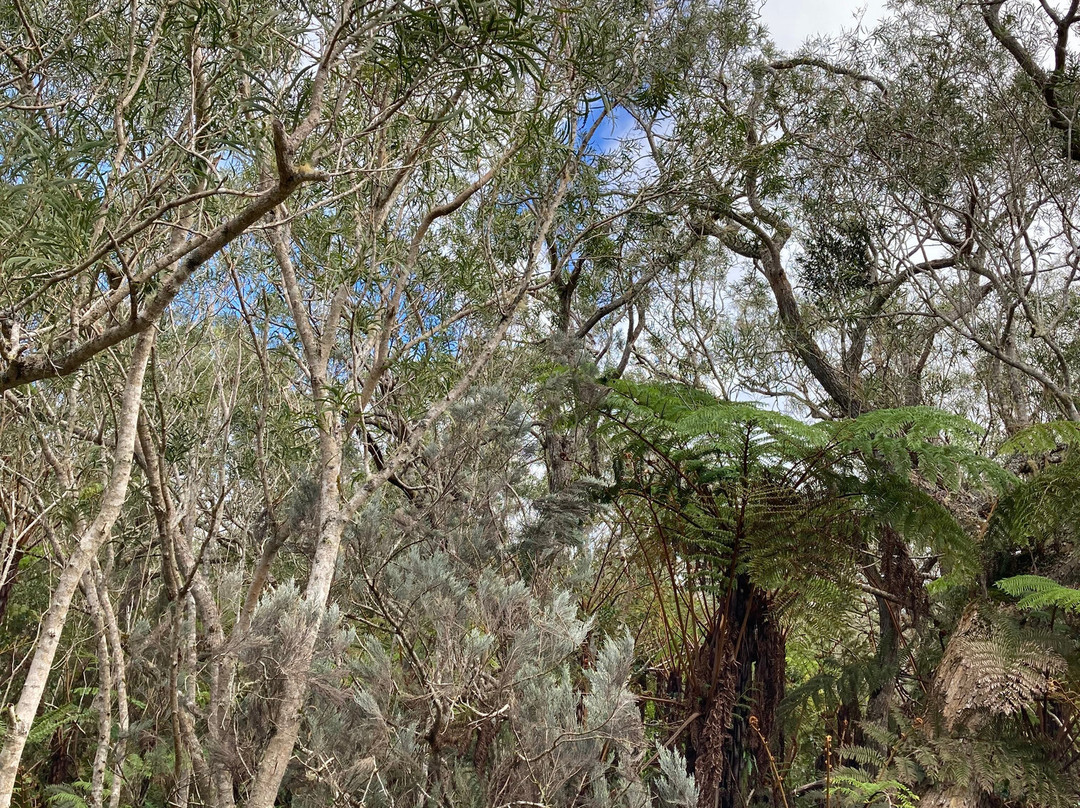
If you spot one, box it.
[0,326,157,808]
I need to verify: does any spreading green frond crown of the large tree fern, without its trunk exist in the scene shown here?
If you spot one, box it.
[609,381,989,607]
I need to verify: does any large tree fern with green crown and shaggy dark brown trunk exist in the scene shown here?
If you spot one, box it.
[612,382,1004,805]
